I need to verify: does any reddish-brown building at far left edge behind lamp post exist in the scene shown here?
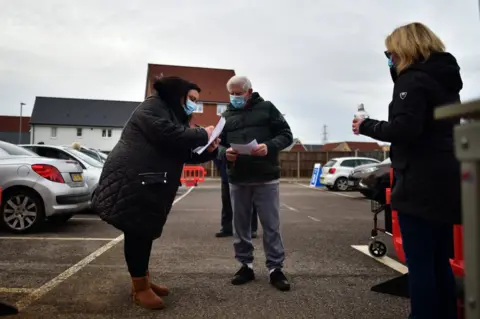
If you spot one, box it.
[0,116,30,144]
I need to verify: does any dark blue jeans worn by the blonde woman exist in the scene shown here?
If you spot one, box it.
[398,213,457,319]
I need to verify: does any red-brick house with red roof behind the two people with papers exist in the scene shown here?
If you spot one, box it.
[145,64,235,126]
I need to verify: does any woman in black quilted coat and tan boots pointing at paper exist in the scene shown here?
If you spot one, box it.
[92,77,218,309]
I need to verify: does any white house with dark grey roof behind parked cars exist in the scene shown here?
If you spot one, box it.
[30,97,140,152]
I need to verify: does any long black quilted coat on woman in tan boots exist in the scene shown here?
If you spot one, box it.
[93,96,217,239]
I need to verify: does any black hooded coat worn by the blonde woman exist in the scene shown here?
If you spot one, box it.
[360,53,463,223]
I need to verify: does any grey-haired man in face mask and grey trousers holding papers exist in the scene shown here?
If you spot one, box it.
[219,76,293,291]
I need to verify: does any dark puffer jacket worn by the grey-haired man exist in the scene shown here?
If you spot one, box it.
[220,92,293,184]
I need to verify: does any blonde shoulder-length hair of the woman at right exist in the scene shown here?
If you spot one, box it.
[385,22,445,72]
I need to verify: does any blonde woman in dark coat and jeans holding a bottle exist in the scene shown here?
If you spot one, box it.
[352,22,463,319]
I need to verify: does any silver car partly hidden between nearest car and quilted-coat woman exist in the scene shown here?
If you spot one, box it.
[20,144,103,198]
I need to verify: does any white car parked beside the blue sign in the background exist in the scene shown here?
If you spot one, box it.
[320,157,380,191]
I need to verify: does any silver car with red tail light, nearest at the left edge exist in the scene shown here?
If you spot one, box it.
[0,141,90,233]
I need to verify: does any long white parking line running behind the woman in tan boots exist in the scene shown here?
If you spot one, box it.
[16,187,194,311]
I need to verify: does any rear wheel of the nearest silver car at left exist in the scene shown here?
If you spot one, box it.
[3,194,38,230]
